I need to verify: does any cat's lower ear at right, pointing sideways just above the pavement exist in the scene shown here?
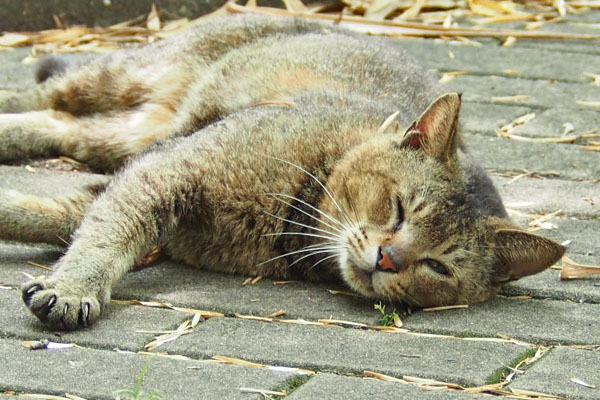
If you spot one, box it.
[495,229,565,283]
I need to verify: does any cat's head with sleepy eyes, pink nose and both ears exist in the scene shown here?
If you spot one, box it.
[327,93,564,307]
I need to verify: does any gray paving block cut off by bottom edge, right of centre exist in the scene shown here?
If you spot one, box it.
[286,374,489,400]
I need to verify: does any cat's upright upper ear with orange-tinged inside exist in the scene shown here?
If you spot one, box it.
[401,93,461,163]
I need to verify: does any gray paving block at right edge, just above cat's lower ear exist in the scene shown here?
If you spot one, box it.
[491,176,600,219]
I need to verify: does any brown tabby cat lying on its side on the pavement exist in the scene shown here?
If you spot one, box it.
[0,16,564,330]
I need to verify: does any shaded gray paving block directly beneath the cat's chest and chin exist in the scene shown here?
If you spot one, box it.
[113,262,381,324]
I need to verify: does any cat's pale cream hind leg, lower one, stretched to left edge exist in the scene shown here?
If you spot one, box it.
[0,103,176,171]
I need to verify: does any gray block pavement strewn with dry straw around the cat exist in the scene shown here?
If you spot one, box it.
[0,8,600,400]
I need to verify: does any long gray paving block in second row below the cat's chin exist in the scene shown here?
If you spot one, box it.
[161,318,528,385]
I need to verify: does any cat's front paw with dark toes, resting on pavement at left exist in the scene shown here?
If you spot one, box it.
[21,278,101,331]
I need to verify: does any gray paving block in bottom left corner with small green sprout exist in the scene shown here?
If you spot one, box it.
[0,339,291,400]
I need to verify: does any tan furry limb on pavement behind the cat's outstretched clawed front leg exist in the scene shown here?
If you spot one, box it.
[0,180,108,247]
